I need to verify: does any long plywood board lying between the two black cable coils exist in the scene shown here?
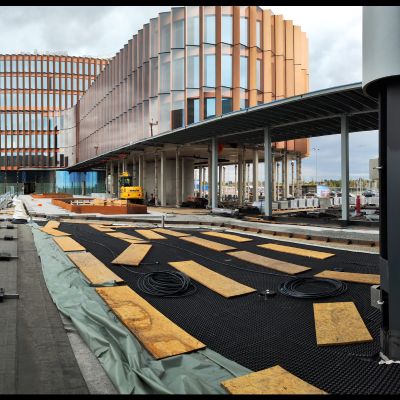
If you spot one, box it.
[168,260,256,297]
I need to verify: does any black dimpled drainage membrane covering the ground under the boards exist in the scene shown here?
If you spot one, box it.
[59,223,400,394]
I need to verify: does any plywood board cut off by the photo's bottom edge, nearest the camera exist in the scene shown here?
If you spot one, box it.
[221,365,326,394]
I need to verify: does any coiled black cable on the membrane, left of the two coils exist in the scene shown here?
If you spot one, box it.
[137,271,197,297]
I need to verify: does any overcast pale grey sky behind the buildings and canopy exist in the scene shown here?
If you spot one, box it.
[0,6,378,178]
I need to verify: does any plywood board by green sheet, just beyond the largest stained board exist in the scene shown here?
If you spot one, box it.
[67,251,123,285]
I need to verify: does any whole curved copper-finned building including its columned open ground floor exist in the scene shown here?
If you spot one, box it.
[60,6,309,205]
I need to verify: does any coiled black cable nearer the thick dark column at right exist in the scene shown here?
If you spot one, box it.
[279,277,347,299]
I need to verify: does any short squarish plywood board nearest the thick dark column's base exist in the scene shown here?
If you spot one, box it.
[313,301,373,346]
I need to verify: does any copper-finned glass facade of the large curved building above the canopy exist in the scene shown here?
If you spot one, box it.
[60,6,309,166]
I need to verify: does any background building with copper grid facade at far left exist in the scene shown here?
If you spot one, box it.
[0,54,108,193]
